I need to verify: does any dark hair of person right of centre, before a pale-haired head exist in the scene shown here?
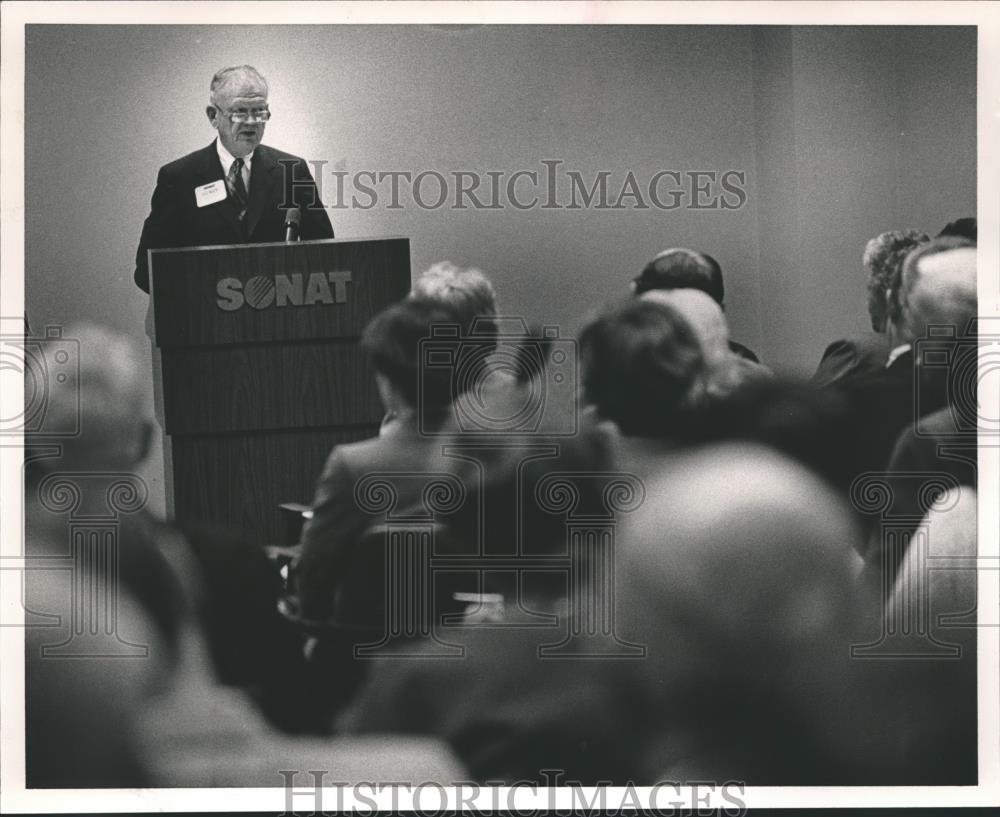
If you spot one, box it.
[580,300,704,437]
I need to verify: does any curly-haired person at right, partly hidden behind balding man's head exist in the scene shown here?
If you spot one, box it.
[812,230,930,386]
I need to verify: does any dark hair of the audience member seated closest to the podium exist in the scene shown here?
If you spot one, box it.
[361,299,461,413]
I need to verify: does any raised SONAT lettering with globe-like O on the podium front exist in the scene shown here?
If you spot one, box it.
[215,270,351,312]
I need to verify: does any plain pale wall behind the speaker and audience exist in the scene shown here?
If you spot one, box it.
[25,25,976,509]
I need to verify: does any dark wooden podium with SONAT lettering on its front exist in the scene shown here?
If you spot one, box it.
[149,238,410,544]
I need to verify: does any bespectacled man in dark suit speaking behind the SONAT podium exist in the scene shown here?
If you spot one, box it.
[135,65,333,292]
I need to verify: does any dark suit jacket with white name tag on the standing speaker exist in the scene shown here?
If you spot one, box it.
[135,142,333,292]
